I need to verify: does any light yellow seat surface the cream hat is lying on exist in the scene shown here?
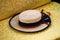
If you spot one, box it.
[0,2,60,40]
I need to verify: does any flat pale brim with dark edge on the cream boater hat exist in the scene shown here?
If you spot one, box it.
[9,14,51,32]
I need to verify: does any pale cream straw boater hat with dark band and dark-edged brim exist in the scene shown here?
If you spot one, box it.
[9,10,51,32]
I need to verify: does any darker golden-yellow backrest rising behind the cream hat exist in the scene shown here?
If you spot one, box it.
[0,0,51,20]
